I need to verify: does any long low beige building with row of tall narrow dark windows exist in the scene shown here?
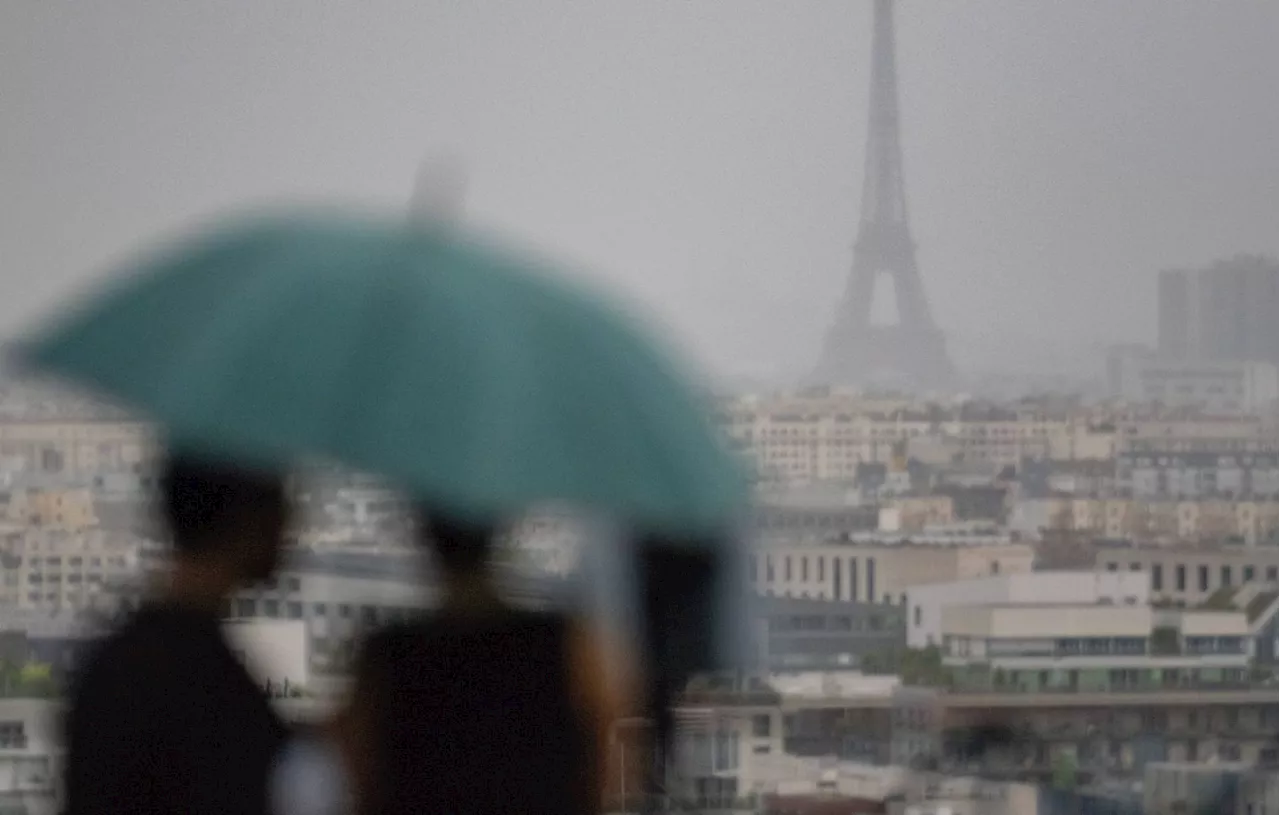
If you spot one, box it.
[750,542,1036,604]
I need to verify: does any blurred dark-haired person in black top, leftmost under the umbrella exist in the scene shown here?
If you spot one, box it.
[67,457,287,815]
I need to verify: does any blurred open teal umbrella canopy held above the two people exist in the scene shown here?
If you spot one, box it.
[18,205,746,531]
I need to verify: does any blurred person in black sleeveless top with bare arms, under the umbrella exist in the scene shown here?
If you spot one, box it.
[335,517,617,815]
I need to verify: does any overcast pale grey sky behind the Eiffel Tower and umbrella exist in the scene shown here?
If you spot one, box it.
[0,0,1280,374]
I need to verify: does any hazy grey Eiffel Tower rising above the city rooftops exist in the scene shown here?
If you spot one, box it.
[810,0,955,388]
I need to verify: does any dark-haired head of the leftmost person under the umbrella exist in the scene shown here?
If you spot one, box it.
[160,453,288,583]
